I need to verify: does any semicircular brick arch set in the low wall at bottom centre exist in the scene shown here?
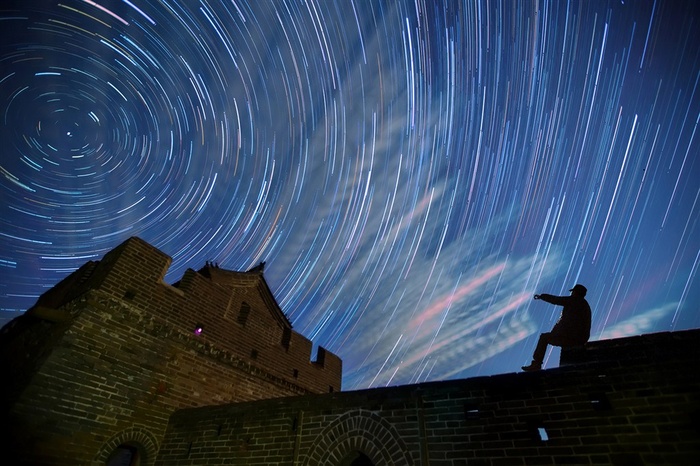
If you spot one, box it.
[304,409,413,466]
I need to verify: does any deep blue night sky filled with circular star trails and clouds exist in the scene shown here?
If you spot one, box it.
[0,0,700,390]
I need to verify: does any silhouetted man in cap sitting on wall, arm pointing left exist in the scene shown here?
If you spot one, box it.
[523,285,591,372]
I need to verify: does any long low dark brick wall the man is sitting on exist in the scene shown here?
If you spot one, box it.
[156,330,700,466]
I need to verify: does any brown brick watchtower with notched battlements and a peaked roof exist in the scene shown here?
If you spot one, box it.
[0,238,342,465]
